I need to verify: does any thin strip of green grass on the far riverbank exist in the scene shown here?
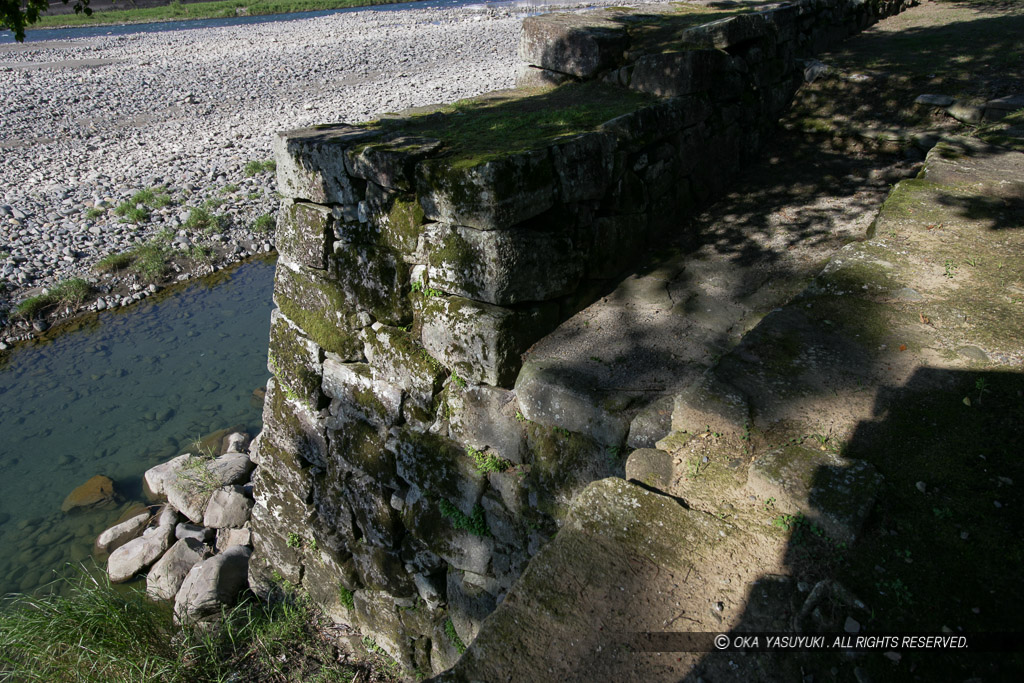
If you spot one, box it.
[30,0,410,31]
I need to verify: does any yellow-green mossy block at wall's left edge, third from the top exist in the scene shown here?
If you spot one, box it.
[273,263,364,360]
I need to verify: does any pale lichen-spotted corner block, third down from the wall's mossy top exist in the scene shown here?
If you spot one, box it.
[423,297,557,386]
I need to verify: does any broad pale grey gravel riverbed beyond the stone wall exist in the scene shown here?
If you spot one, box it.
[0,0,663,346]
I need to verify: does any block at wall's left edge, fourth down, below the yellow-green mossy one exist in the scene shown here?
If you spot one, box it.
[267,309,324,409]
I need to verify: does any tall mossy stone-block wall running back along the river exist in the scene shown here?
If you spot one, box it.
[250,0,910,673]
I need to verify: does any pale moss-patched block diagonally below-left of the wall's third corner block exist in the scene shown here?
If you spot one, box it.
[362,326,443,413]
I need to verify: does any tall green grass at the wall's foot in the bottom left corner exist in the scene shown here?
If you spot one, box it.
[0,570,366,683]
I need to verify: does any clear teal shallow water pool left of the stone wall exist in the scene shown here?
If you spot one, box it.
[0,261,273,593]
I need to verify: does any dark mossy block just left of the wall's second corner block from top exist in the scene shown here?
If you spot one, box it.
[331,243,412,327]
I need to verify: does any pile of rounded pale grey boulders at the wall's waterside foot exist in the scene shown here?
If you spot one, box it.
[96,433,254,622]
